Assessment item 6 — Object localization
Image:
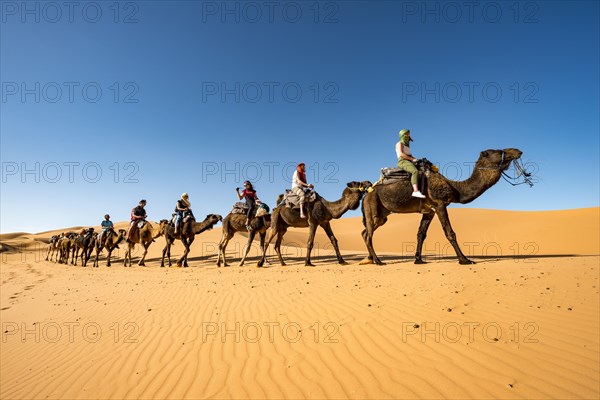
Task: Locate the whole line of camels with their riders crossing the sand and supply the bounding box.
[46,130,533,267]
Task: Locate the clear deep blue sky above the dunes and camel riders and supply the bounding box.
[0,1,600,232]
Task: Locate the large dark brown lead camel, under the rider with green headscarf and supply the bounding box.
[361,148,523,265]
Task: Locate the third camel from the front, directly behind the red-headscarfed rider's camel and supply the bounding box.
[217,208,271,267]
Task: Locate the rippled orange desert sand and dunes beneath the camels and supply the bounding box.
[0,208,600,399]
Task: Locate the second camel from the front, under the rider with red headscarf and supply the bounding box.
[258,181,371,267]
